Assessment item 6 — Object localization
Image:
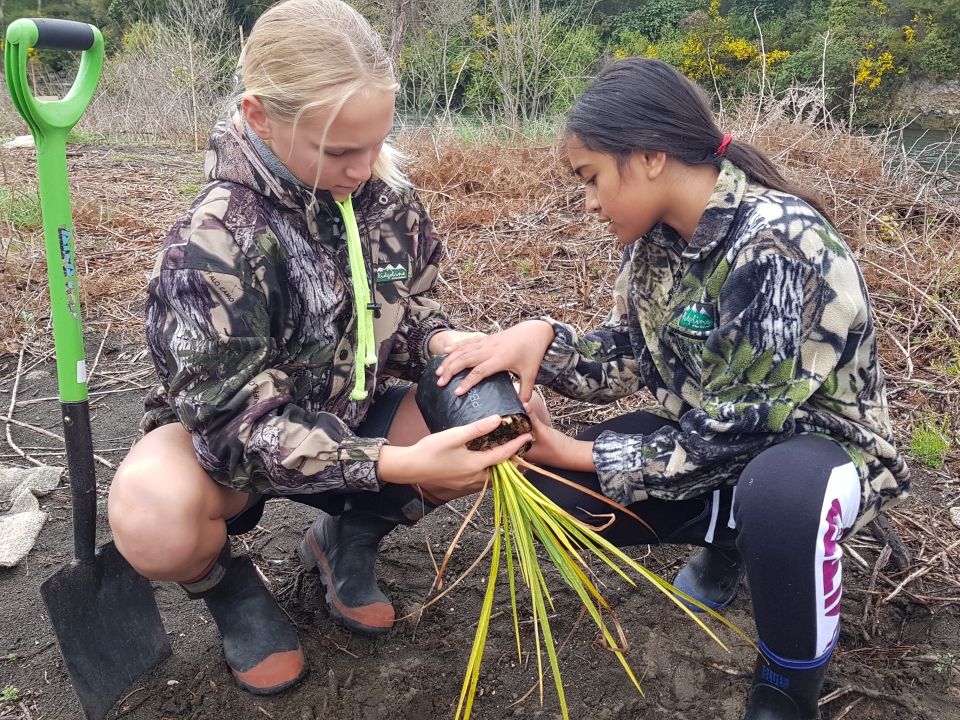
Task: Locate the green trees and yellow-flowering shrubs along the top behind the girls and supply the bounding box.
[0,0,960,140]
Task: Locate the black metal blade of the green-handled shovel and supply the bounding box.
[40,543,170,720]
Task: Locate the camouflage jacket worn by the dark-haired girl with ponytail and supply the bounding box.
[538,161,909,527]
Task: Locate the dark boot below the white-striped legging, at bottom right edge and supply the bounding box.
[744,653,832,720]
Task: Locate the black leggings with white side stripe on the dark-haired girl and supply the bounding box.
[530,411,860,666]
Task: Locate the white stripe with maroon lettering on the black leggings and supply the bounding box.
[813,462,860,657]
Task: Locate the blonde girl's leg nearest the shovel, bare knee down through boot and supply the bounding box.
[108,423,306,695]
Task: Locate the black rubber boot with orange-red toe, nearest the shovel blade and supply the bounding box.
[181,542,307,695]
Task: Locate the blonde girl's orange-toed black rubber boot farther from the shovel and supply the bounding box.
[300,484,437,635]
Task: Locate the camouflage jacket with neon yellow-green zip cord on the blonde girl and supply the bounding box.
[143,121,449,494]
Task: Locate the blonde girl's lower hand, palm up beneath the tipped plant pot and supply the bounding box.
[378,415,533,500]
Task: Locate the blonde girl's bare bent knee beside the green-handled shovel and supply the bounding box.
[107,423,249,582]
